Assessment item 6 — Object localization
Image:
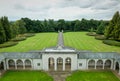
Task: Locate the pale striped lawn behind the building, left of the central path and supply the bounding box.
[0,33,58,52]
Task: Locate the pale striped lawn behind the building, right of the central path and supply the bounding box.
[64,32,120,52]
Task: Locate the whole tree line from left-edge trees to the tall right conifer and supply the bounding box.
[0,16,108,44]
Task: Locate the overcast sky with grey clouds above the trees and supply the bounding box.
[0,0,120,20]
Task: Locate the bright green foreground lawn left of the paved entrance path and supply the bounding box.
[0,71,53,81]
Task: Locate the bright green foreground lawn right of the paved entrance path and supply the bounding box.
[66,71,120,81]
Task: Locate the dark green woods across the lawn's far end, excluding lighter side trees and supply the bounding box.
[21,18,108,32]
